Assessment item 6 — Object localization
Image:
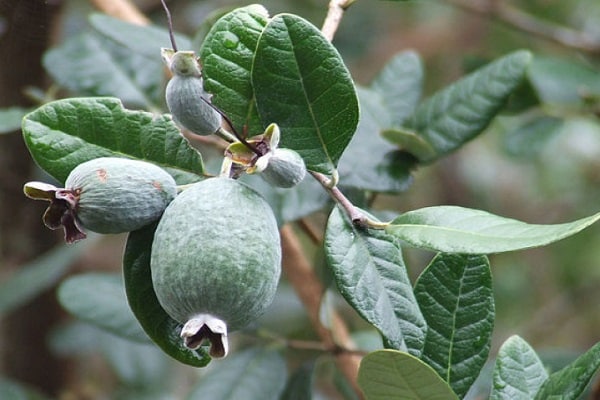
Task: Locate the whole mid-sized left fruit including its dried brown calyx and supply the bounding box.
[23,157,177,243]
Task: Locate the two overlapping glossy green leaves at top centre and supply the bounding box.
[200,5,358,174]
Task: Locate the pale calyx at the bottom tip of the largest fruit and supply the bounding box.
[180,314,229,358]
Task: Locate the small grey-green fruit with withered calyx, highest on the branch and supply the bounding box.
[161,48,222,136]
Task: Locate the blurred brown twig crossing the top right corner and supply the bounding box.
[446,0,600,54]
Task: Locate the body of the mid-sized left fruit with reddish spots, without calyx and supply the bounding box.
[66,157,177,233]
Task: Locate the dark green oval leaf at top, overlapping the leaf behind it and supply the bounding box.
[252,14,358,174]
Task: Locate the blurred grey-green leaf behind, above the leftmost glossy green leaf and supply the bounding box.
[43,33,164,110]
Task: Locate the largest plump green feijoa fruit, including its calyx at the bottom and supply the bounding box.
[150,177,281,358]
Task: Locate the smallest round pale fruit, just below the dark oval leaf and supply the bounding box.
[260,148,306,188]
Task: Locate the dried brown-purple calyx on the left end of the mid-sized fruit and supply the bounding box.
[23,181,87,244]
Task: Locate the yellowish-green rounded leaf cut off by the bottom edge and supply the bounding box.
[358,350,458,400]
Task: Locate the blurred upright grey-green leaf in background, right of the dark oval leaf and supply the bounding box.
[370,51,423,128]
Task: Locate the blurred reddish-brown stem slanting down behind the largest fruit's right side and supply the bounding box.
[281,225,362,398]
